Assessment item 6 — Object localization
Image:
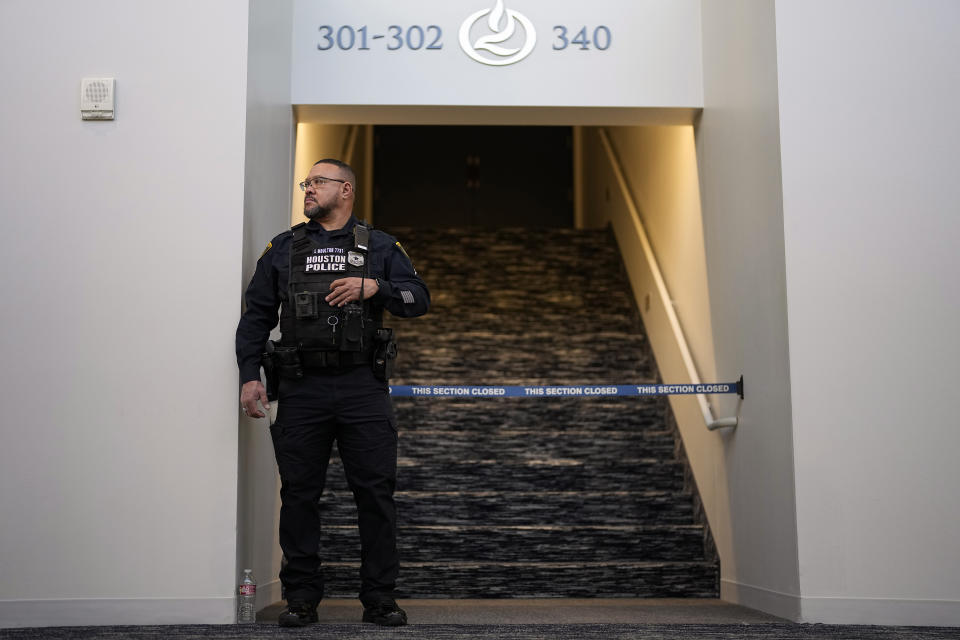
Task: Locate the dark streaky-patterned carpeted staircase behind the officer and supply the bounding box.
[323,229,719,598]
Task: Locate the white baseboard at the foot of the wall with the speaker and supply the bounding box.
[0,597,236,628]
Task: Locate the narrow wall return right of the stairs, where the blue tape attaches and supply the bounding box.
[697,0,809,618]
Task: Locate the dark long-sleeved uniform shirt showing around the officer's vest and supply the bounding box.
[237,216,430,383]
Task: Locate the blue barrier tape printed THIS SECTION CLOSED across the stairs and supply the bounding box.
[390,378,743,398]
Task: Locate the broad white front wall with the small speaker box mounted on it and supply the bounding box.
[0,0,247,626]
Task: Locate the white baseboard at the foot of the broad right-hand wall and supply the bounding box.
[801,598,960,627]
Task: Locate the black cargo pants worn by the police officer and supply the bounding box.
[270,365,400,605]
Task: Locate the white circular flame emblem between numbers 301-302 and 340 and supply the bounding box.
[460,0,537,67]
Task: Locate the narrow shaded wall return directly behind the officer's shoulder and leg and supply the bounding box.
[238,0,294,607]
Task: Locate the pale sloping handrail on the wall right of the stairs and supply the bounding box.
[599,127,743,431]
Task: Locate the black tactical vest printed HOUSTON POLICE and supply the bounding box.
[280,223,383,366]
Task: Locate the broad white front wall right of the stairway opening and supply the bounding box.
[776,0,960,625]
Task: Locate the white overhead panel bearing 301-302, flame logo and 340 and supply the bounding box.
[291,0,703,108]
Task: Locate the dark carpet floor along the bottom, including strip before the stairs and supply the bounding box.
[0,598,960,640]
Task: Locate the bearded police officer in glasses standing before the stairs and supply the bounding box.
[237,159,430,626]
